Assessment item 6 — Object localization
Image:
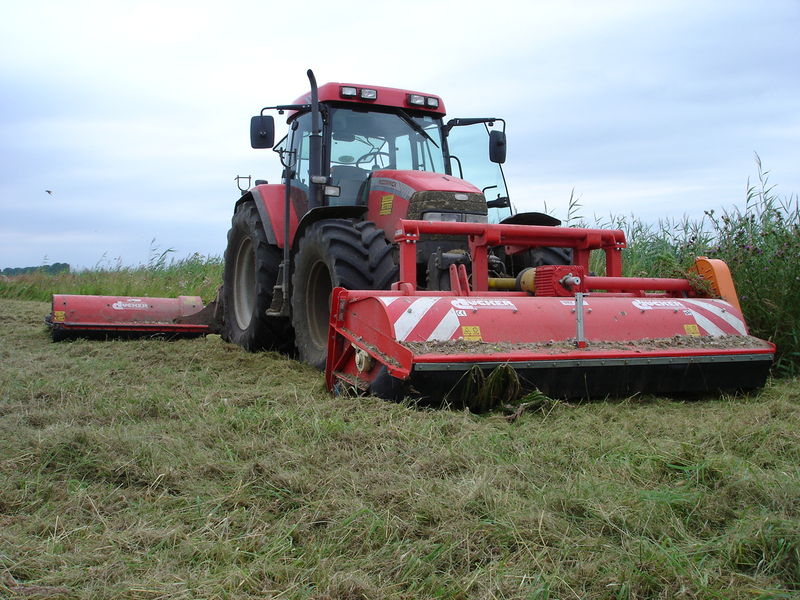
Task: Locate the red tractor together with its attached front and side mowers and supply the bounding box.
[48,71,775,406]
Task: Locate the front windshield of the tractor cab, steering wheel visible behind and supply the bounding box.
[330,108,445,173]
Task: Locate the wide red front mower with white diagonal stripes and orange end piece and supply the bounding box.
[326,220,775,402]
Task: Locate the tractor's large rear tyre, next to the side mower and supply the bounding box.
[222,202,294,352]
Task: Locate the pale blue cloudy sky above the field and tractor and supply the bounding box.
[0,0,800,268]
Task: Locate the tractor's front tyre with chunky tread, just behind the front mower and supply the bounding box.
[292,219,397,369]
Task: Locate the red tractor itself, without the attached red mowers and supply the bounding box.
[222,71,569,368]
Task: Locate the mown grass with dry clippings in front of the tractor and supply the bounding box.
[0,299,800,600]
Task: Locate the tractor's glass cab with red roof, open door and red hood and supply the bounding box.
[251,83,511,228]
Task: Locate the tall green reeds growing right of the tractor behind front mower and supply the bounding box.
[580,155,800,375]
